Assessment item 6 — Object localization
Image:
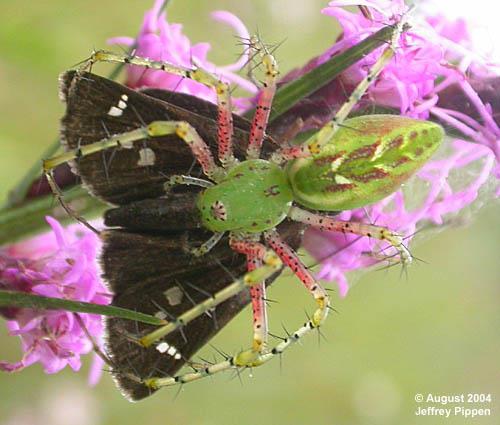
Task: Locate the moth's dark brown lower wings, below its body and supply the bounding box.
[102,230,249,400]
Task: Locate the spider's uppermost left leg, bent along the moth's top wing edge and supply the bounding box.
[82,50,236,168]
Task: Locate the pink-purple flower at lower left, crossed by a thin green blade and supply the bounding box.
[0,217,111,383]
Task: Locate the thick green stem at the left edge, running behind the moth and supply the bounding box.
[0,187,106,246]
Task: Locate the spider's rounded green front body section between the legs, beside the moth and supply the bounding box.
[198,159,293,233]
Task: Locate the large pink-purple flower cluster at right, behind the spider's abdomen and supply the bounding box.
[304,0,500,296]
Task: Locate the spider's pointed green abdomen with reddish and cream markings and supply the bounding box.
[287,115,444,211]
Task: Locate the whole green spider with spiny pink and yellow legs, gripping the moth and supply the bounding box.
[44,17,443,389]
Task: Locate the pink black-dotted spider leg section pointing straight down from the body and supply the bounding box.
[229,235,268,355]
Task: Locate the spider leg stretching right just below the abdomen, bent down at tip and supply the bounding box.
[288,206,412,265]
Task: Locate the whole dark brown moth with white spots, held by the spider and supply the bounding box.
[61,71,303,400]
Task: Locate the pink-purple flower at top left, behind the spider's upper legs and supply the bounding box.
[108,0,257,108]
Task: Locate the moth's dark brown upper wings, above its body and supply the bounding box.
[60,71,276,205]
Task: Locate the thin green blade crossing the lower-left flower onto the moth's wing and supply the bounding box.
[0,291,167,326]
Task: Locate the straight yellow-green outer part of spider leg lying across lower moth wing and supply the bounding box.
[137,250,282,347]
